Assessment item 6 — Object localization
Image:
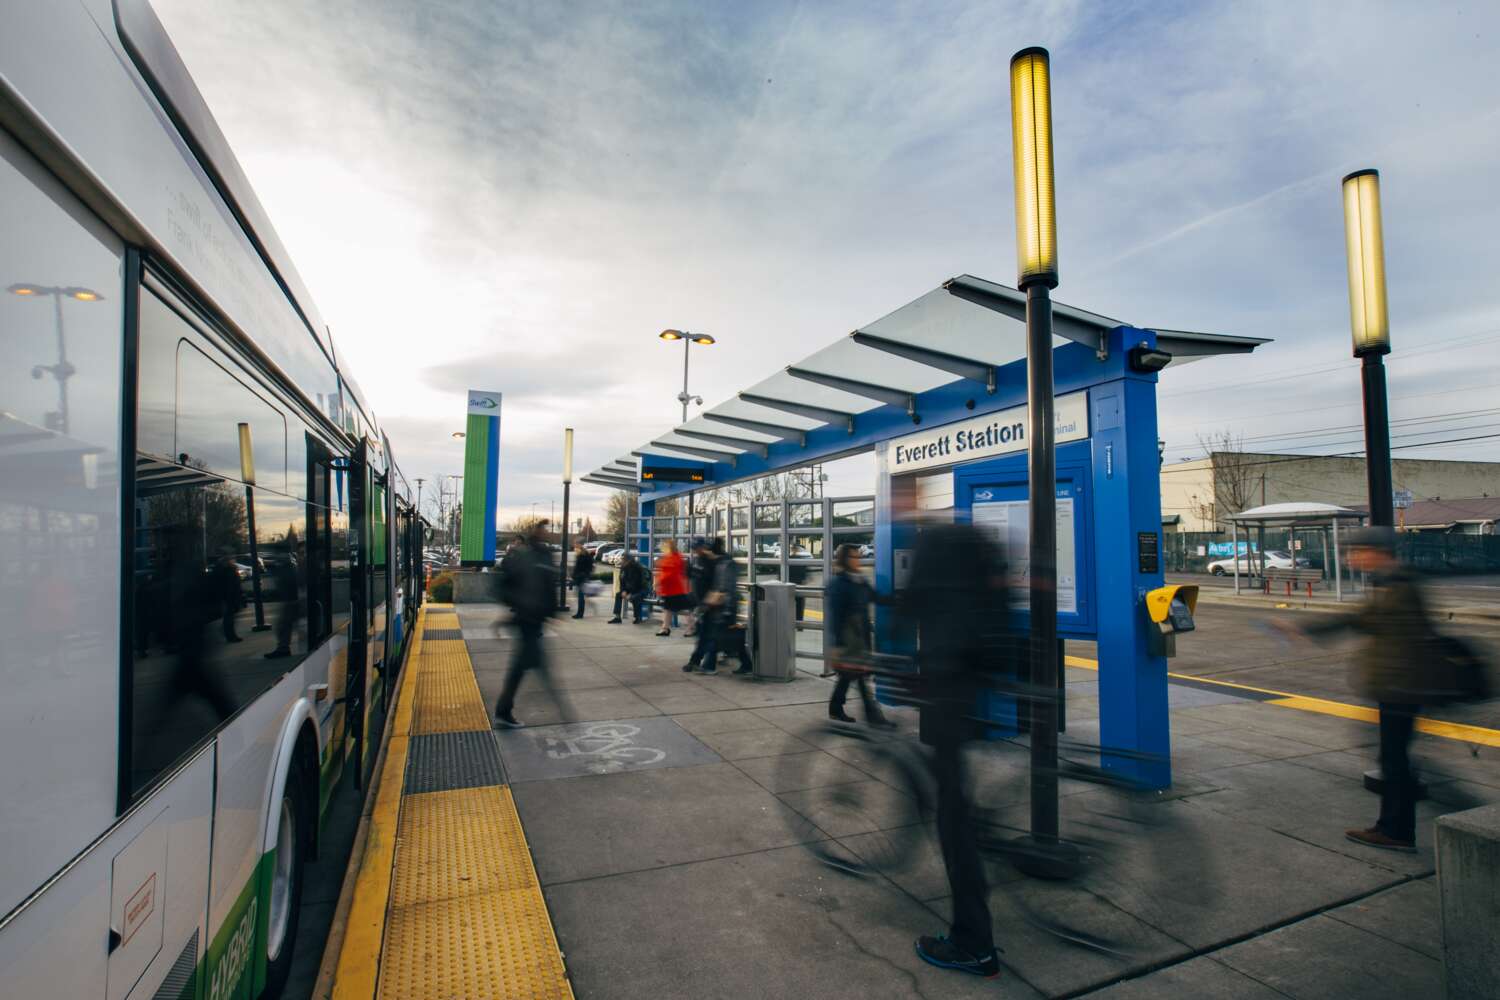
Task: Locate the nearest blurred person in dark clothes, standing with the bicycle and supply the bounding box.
[905,525,1014,978]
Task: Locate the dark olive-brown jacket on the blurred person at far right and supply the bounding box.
[1304,567,1439,705]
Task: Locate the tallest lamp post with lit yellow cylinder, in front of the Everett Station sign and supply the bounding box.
[1011,48,1071,877]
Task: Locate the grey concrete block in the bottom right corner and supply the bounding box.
[1437,805,1500,1000]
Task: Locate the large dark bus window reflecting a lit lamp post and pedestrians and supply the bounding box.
[129,289,308,792]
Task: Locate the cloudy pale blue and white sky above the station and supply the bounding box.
[155,0,1500,520]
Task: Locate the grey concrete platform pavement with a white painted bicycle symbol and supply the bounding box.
[458,604,1500,1000]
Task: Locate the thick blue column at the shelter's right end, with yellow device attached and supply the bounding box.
[1089,327,1172,789]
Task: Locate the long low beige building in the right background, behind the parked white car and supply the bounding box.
[1161,451,1500,534]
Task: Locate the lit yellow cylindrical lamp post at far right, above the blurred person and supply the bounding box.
[1344,169,1395,528]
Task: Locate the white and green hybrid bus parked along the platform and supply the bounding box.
[0,0,420,1000]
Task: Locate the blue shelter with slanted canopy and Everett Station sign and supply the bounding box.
[585,274,1266,787]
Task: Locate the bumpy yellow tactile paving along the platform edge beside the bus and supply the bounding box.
[333,606,573,1000]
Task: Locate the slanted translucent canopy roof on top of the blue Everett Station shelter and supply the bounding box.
[582,274,1266,489]
